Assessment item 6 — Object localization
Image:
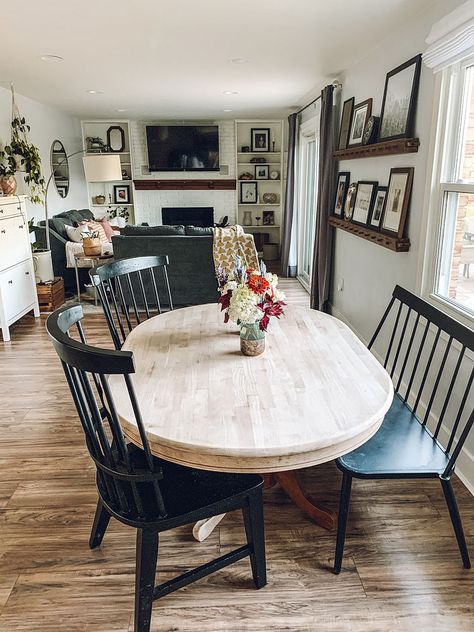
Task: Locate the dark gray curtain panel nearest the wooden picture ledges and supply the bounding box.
[310,85,337,312]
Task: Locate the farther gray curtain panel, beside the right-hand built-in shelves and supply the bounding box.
[281,114,298,277]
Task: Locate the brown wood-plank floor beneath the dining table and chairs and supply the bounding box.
[0,280,474,632]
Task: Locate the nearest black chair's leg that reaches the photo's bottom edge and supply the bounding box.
[134,529,159,632]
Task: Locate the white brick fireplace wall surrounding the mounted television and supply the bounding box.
[130,121,235,225]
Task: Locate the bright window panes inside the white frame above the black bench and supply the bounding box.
[430,59,474,318]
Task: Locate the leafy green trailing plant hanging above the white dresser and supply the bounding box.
[0,116,45,204]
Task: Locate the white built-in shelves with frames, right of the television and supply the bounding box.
[235,119,284,255]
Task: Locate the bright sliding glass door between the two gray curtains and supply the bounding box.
[298,118,319,290]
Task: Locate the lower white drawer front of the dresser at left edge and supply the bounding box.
[0,261,36,321]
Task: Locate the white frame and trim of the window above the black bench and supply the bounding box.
[417,57,474,327]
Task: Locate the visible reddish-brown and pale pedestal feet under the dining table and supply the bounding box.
[193,470,336,542]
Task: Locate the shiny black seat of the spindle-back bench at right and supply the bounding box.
[336,395,449,478]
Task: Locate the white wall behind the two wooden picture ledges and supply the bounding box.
[332,0,474,490]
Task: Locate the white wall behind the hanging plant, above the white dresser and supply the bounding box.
[0,88,88,223]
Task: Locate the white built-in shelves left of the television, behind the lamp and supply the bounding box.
[82,120,134,223]
